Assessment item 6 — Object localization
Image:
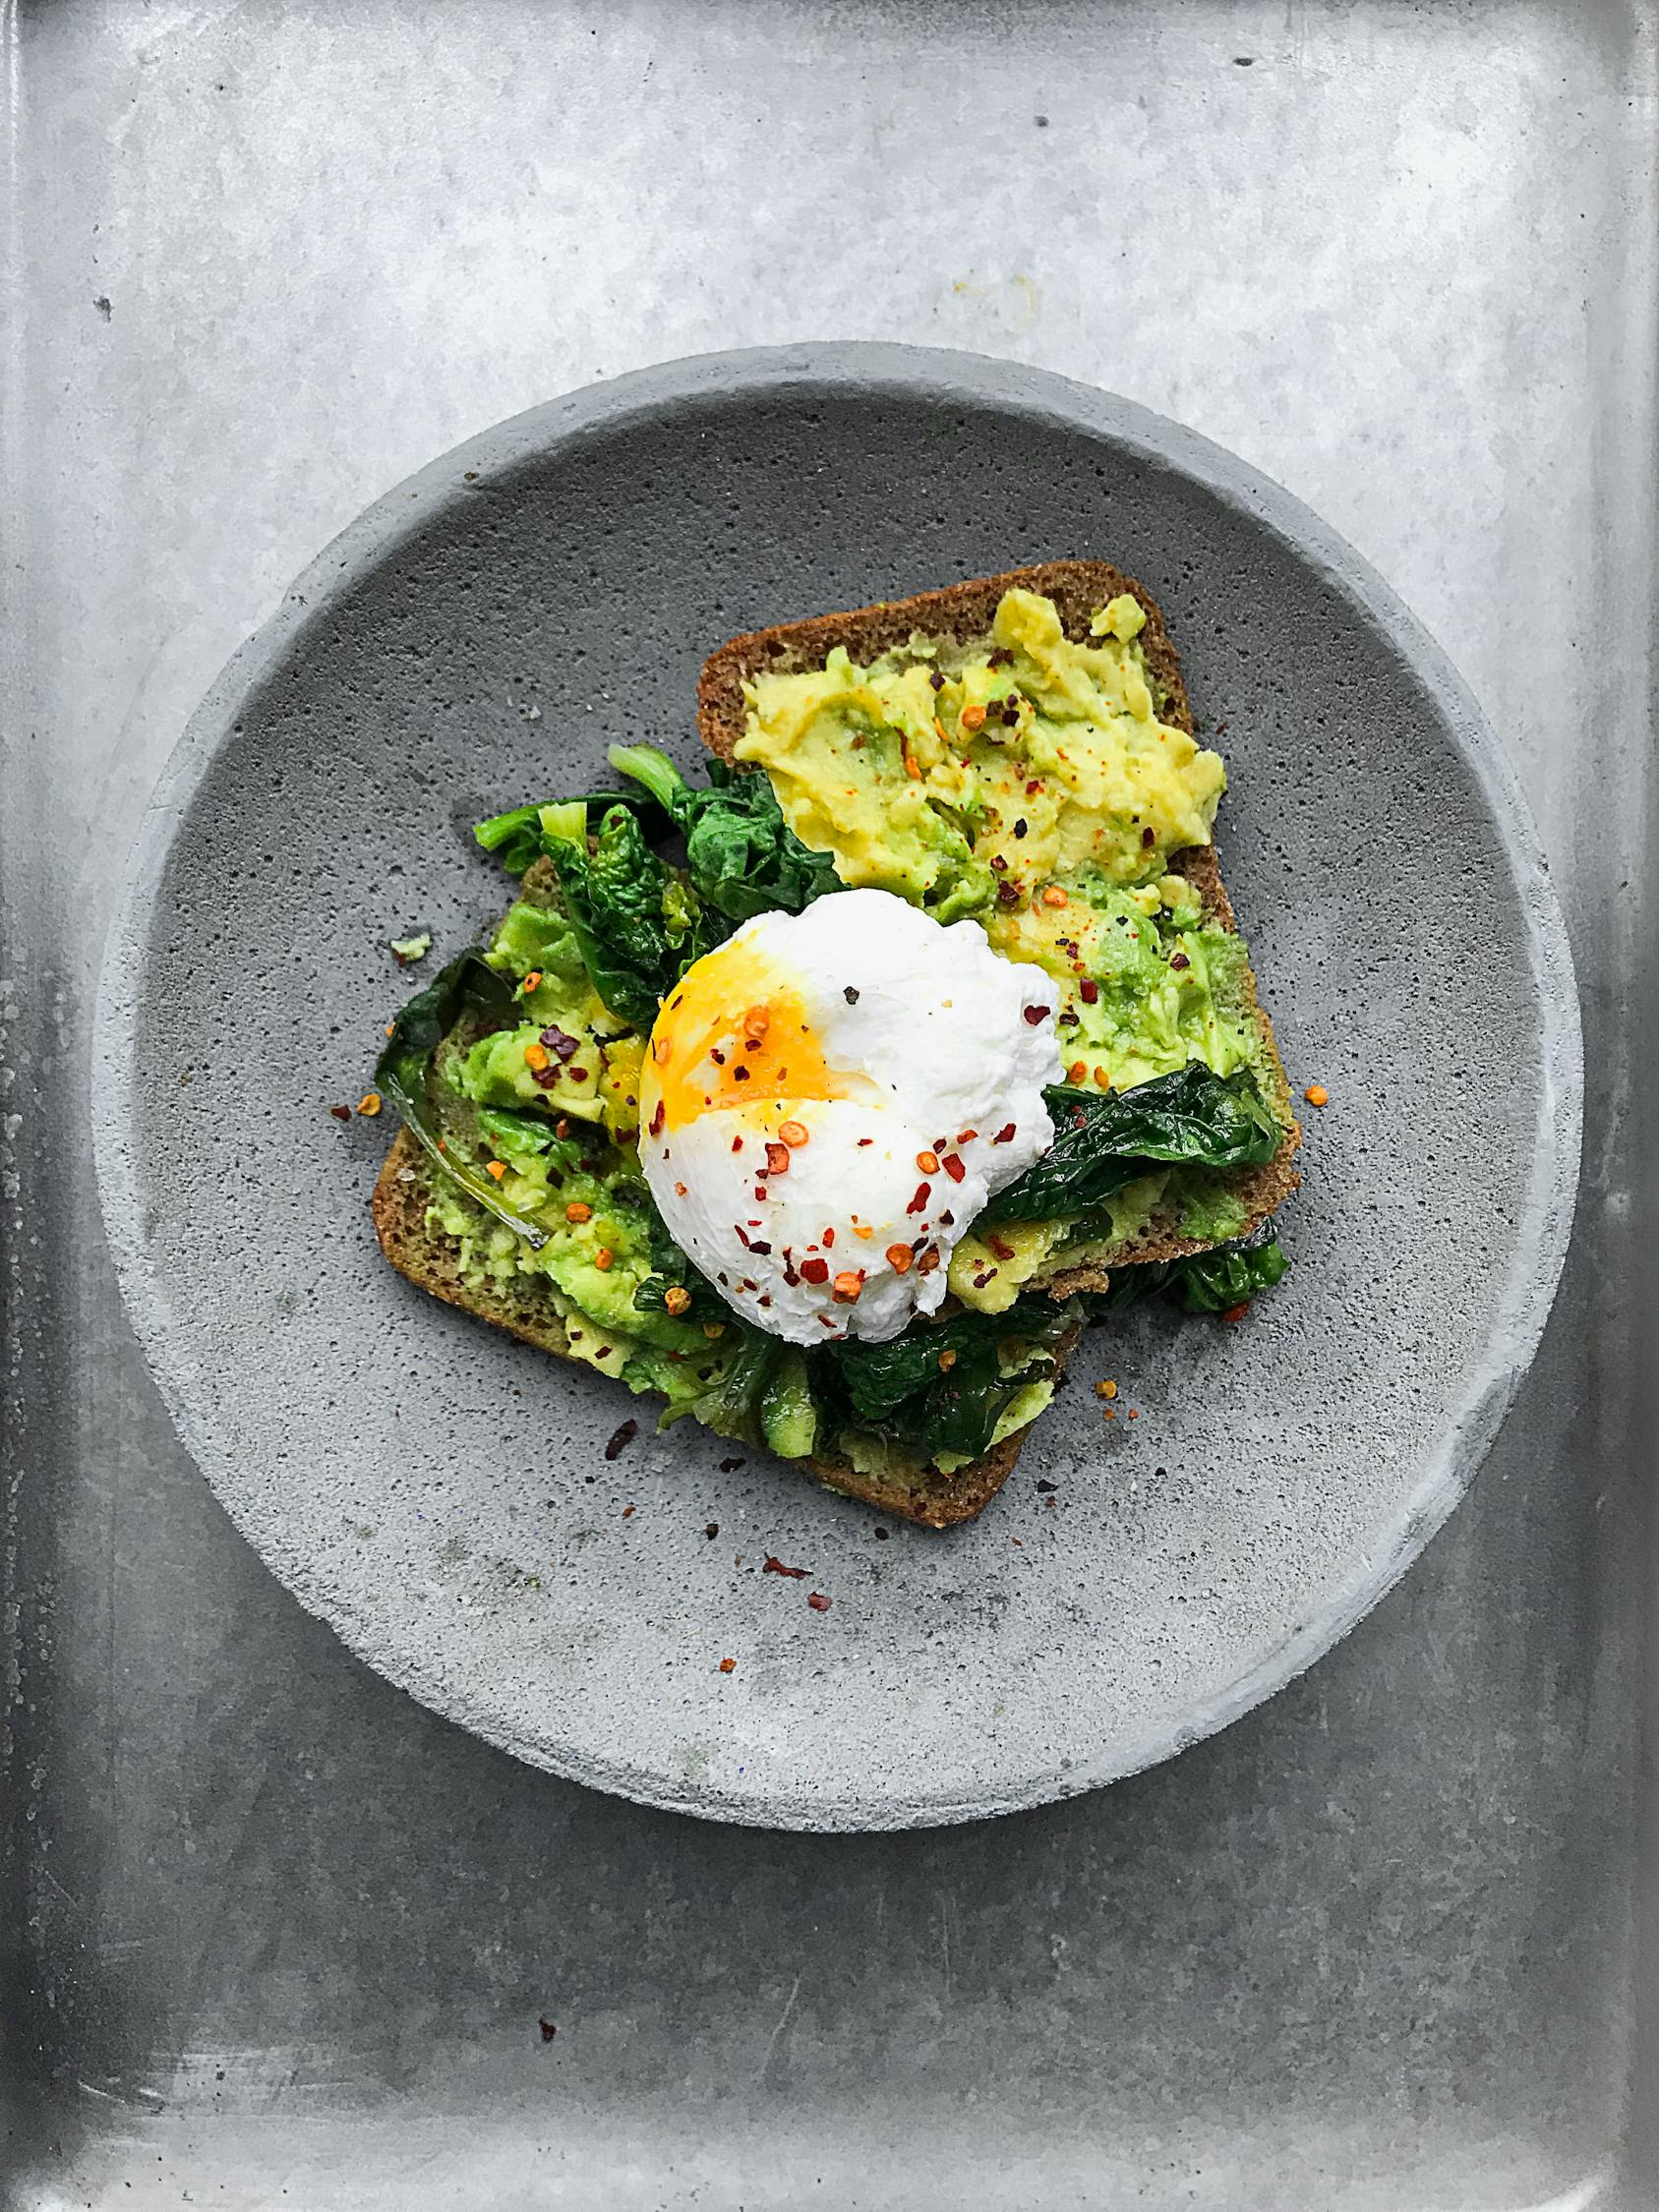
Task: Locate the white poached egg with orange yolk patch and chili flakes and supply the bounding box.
[639,890,1059,1345]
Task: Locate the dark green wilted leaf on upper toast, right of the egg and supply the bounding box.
[979,1060,1283,1228]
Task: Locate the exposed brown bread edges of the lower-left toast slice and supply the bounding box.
[372,1131,1075,1529]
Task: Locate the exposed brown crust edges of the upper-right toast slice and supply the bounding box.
[697,559,1301,1299]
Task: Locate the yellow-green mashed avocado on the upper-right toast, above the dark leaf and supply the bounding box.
[737,591,1263,1088]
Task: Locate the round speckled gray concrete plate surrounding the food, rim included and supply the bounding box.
[95,347,1579,1828]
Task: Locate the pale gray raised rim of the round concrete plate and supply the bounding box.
[90,341,1584,1834]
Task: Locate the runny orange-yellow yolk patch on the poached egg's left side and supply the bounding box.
[641,943,869,1131]
